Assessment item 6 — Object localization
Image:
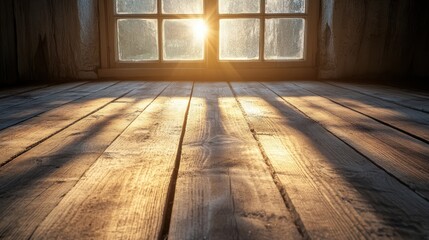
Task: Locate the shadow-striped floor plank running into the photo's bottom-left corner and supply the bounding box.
[0,80,167,239]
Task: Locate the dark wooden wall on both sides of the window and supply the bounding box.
[0,0,429,85]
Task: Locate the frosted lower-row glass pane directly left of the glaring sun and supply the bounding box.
[163,19,205,60]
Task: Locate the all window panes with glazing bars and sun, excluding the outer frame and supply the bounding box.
[111,0,309,66]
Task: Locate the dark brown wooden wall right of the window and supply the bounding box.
[319,0,429,84]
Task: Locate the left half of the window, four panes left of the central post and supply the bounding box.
[115,0,205,62]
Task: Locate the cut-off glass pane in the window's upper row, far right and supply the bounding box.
[265,0,305,13]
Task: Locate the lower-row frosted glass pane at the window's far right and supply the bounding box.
[264,18,305,60]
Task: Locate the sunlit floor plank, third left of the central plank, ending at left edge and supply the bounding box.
[0,82,144,166]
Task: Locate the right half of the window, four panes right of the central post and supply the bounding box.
[219,0,306,60]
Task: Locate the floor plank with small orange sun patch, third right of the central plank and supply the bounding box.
[295,82,429,143]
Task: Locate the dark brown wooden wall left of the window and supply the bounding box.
[0,0,99,85]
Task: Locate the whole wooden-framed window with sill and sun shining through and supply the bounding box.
[100,0,319,79]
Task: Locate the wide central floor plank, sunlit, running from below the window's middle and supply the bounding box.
[168,83,301,239]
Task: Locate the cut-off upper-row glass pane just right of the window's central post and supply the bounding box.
[219,0,261,14]
